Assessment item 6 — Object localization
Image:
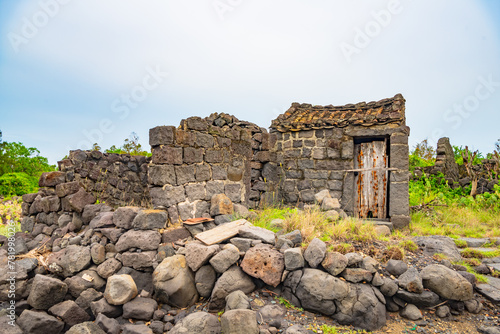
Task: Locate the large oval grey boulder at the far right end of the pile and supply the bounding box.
[420,264,474,301]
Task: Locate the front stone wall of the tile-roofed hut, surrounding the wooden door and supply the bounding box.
[276,124,409,227]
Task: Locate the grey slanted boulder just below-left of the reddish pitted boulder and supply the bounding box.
[209,266,255,311]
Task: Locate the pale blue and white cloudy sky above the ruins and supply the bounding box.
[0,0,500,163]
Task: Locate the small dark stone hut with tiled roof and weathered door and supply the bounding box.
[270,94,410,227]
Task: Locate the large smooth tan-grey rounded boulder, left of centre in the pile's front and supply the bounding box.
[153,255,199,308]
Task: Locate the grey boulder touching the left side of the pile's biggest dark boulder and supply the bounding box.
[296,269,349,316]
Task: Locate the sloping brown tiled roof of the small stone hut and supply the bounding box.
[271,94,405,132]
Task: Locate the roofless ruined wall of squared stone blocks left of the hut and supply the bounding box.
[149,114,276,221]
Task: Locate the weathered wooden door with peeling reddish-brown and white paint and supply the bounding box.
[354,140,388,219]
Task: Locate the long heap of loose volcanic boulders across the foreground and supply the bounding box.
[0,189,496,334]
